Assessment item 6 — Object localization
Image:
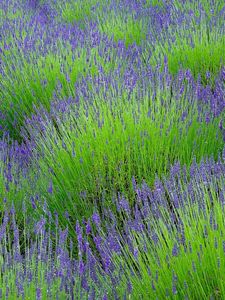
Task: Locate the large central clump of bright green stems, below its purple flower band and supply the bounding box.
[28,79,224,222]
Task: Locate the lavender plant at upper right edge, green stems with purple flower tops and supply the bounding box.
[144,0,225,86]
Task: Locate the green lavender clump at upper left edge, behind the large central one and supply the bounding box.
[0,38,120,138]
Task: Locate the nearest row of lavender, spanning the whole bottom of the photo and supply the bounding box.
[0,150,225,299]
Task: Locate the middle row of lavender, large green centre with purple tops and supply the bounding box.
[0,62,225,227]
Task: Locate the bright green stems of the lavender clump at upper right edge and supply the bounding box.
[150,22,225,86]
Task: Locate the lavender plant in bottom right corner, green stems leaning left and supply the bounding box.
[97,151,225,299]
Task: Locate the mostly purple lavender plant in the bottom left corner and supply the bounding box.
[0,206,112,299]
